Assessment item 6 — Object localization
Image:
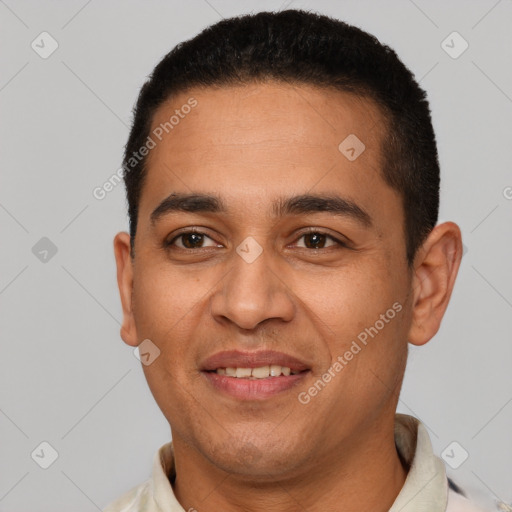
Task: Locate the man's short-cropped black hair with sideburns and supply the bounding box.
[123,9,440,267]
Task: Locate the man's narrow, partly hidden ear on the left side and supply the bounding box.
[114,232,139,347]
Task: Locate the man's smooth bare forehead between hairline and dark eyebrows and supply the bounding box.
[139,82,400,230]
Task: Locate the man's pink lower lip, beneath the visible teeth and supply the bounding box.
[201,371,309,400]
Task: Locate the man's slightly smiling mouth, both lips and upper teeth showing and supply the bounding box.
[201,351,311,400]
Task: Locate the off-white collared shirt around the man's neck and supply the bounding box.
[103,413,492,512]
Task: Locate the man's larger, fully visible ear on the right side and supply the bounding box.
[408,222,462,345]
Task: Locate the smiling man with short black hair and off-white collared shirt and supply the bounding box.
[106,10,490,512]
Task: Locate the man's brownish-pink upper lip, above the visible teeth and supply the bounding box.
[201,350,310,371]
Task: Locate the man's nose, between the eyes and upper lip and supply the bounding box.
[211,245,295,329]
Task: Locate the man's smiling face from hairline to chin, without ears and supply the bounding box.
[122,83,411,478]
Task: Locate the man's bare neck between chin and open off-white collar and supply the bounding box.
[173,418,407,512]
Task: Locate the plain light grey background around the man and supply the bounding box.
[0,0,512,512]
